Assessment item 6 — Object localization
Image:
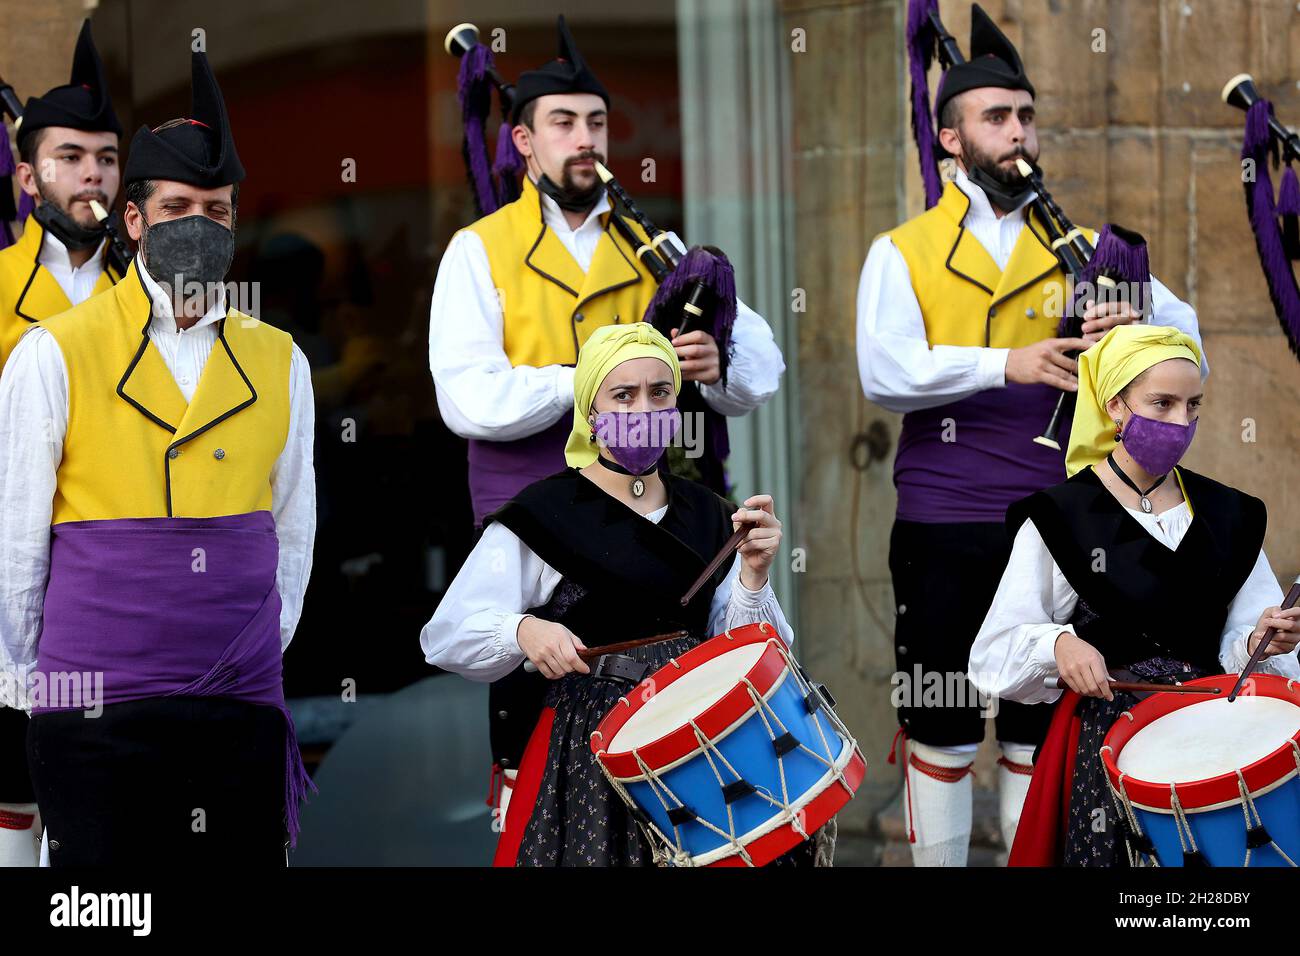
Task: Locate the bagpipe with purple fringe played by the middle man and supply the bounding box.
[443,23,736,494]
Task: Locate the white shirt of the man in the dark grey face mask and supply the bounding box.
[0,261,316,706]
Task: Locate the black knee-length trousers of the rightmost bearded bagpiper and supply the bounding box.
[889,520,1052,747]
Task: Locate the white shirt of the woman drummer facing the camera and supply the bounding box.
[420,496,794,680]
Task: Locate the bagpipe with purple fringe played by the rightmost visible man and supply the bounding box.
[906,0,1151,450]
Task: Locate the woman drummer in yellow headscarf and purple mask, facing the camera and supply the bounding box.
[420,323,815,866]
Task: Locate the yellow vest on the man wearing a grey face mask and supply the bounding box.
[42,261,293,524]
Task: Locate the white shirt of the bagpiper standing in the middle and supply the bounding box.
[429,182,785,441]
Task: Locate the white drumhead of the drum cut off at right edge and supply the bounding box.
[1117,697,1300,783]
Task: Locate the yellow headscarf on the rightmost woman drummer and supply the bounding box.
[1065,325,1201,476]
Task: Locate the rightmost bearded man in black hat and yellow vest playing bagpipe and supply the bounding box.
[857,0,1199,866]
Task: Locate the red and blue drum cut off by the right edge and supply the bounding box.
[1101,674,1300,866]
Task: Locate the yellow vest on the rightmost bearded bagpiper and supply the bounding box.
[887,182,1096,349]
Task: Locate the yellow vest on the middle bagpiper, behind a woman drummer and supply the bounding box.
[465,176,655,367]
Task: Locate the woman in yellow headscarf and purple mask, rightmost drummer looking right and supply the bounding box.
[970,325,1300,866]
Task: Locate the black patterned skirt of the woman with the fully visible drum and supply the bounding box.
[512,637,816,866]
